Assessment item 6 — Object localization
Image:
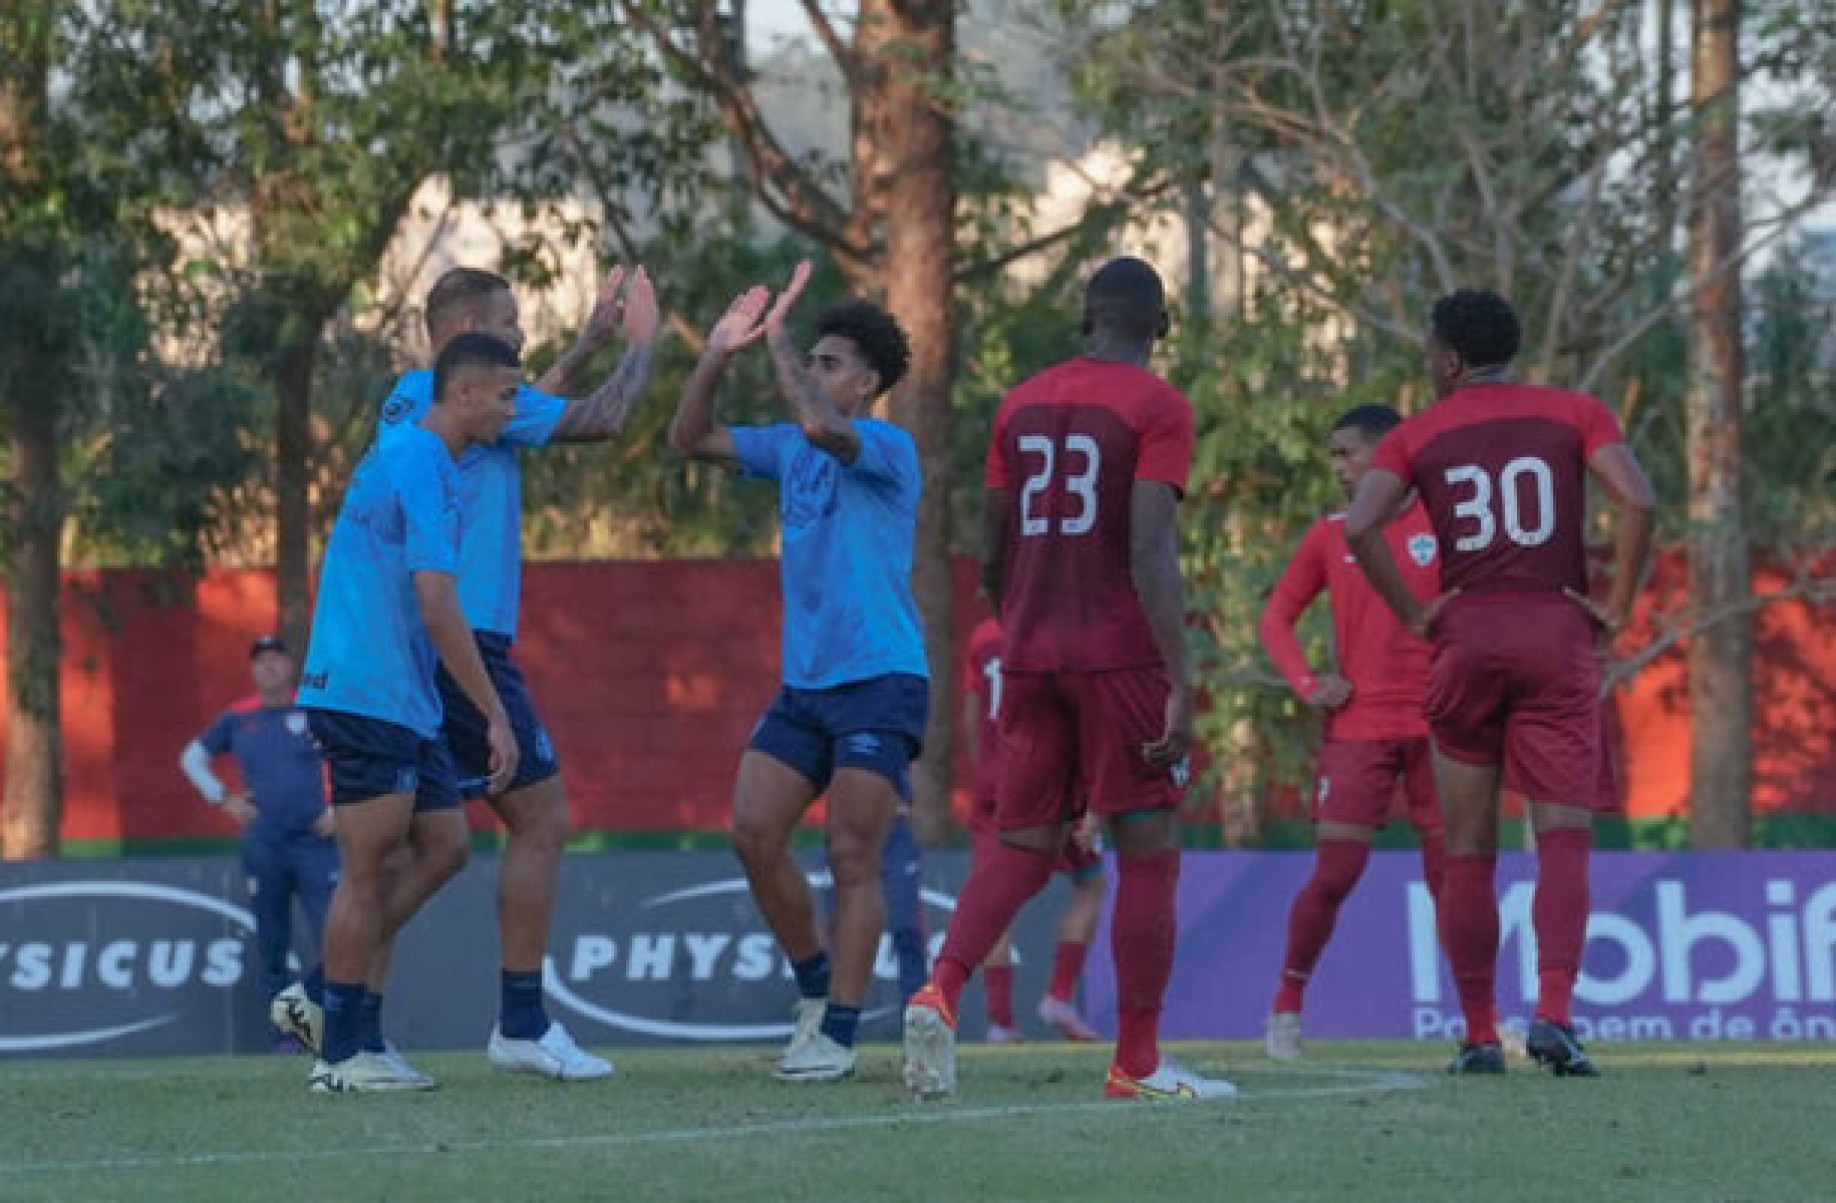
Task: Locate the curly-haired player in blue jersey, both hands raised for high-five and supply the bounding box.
[670,263,929,1082]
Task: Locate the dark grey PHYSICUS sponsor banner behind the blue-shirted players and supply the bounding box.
[0,852,1067,1058]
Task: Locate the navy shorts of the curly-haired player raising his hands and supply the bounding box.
[747,672,931,803]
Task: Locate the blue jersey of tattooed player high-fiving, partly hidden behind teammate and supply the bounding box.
[376,369,567,639]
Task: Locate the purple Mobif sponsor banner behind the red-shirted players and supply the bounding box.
[1085,852,1836,1041]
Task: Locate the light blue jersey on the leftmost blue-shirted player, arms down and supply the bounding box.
[299,426,459,738]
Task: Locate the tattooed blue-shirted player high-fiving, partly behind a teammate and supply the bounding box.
[277,268,659,1082]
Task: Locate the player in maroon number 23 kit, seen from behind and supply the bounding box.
[905,259,1236,1098]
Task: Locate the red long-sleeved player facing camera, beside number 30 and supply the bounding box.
[1261,406,1441,1062]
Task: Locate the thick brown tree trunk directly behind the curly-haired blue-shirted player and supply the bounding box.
[877,0,957,845]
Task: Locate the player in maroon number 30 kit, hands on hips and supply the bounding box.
[1346,290,1656,1076]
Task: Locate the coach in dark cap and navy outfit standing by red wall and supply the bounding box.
[178,635,338,1052]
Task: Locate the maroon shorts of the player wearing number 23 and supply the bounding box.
[995,667,1186,832]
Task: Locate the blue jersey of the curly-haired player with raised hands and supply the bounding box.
[733,419,931,689]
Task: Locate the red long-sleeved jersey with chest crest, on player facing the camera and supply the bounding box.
[1259,501,1441,740]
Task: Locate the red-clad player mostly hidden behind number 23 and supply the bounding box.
[962,619,1109,1045]
